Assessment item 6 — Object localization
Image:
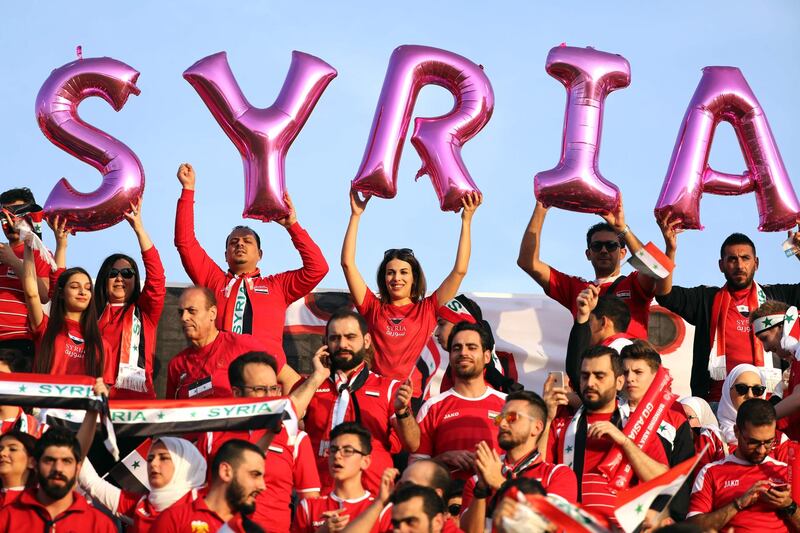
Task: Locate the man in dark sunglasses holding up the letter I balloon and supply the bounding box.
[517,200,660,339]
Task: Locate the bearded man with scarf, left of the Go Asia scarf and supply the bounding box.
[543,346,668,522]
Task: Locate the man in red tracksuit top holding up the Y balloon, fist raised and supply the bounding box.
[175,163,328,359]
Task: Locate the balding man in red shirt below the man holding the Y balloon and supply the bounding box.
[167,287,299,399]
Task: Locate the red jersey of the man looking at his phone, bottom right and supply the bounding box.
[687,454,789,532]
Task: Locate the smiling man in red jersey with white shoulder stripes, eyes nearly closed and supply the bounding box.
[395,322,506,479]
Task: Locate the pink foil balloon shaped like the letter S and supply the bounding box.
[36,57,144,231]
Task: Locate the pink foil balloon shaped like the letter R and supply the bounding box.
[352,45,494,211]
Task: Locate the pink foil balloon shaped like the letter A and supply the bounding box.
[655,67,800,231]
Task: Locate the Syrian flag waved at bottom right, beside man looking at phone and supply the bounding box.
[614,444,708,533]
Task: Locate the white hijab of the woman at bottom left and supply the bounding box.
[147,437,206,513]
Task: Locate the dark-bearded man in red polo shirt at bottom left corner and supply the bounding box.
[0,428,117,533]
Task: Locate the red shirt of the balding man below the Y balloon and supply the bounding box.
[162,331,286,400]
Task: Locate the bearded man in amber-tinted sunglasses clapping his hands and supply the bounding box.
[461,391,578,533]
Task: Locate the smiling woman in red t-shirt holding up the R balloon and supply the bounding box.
[342,191,483,381]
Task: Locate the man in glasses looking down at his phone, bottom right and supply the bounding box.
[688,398,800,532]
